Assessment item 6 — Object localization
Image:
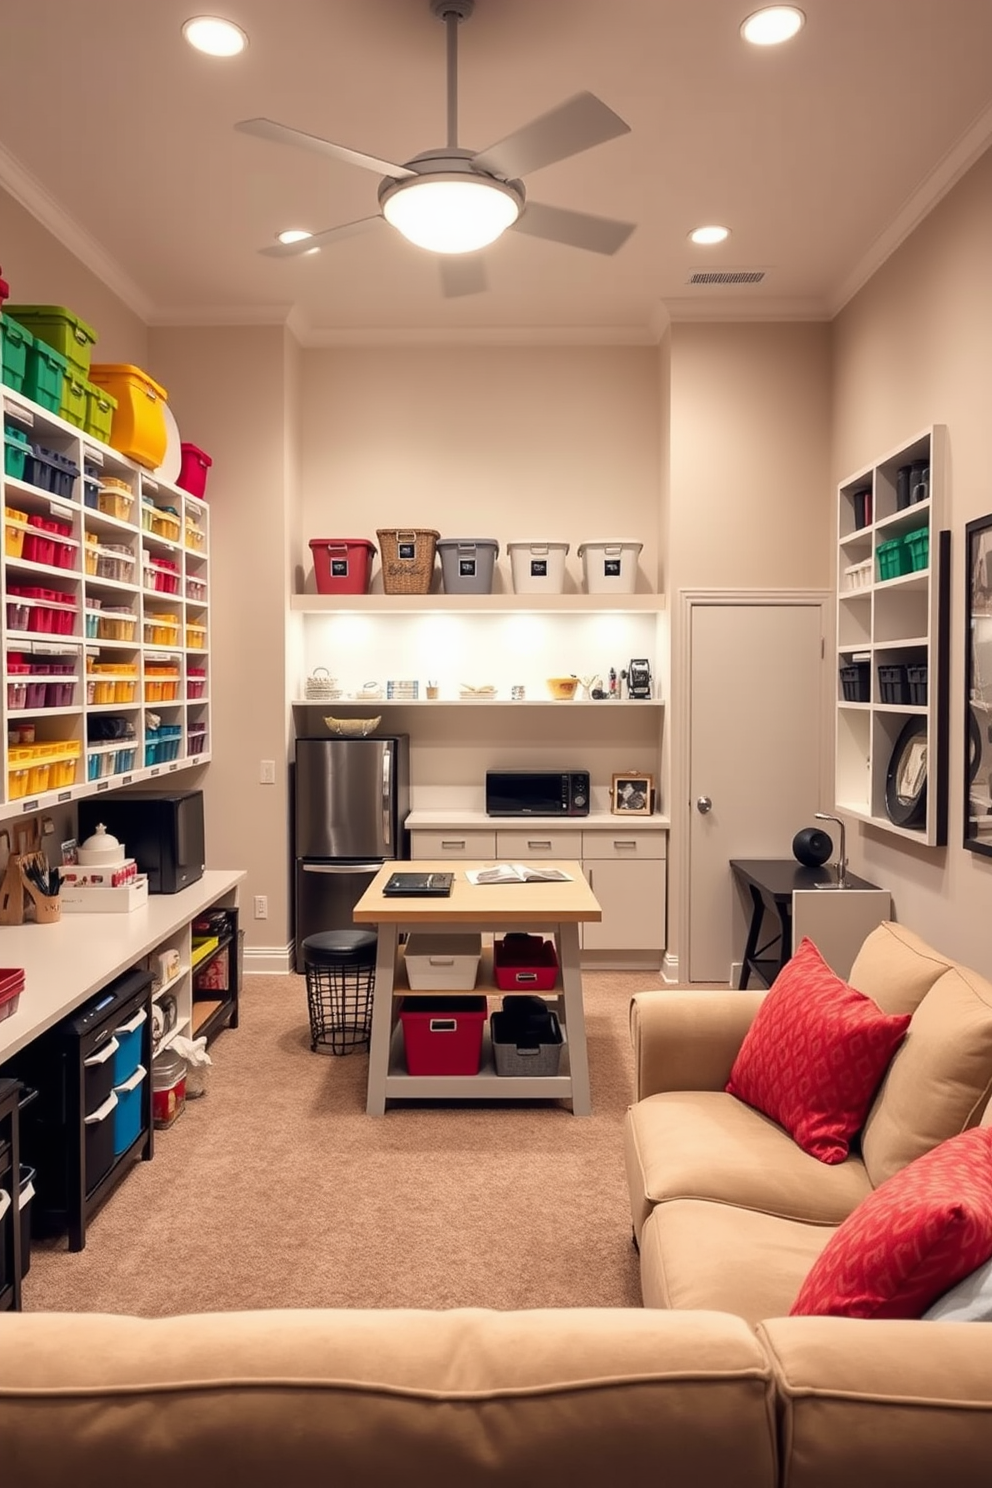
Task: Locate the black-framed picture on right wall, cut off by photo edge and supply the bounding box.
[964,515,992,857]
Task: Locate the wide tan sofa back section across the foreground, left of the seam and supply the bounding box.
[0,1308,775,1488]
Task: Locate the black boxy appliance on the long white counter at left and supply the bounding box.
[79,790,205,894]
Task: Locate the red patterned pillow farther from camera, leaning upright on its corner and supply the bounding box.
[726,937,910,1164]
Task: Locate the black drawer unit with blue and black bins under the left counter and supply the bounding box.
[4,969,153,1250]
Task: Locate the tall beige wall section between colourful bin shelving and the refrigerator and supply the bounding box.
[149,326,292,949]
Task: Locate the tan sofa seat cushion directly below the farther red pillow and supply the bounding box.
[625,1091,872,1238]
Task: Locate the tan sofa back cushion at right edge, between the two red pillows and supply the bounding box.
[861,966,992,1187]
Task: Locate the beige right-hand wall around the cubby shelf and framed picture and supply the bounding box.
[831,142,992,975]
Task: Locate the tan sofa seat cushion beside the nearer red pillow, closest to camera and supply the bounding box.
[641,1199,836,1327]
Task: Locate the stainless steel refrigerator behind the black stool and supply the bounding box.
[293,734,410,972]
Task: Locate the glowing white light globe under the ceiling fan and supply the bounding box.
[379,176,524,253]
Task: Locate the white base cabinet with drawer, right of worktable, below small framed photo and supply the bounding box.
[582,829,668,955]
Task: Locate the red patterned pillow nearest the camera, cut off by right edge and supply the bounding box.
[790,1126,992,1317]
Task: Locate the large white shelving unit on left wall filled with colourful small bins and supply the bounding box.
[0,377,210,817]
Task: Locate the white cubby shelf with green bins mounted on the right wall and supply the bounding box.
[834,424,950,847]
